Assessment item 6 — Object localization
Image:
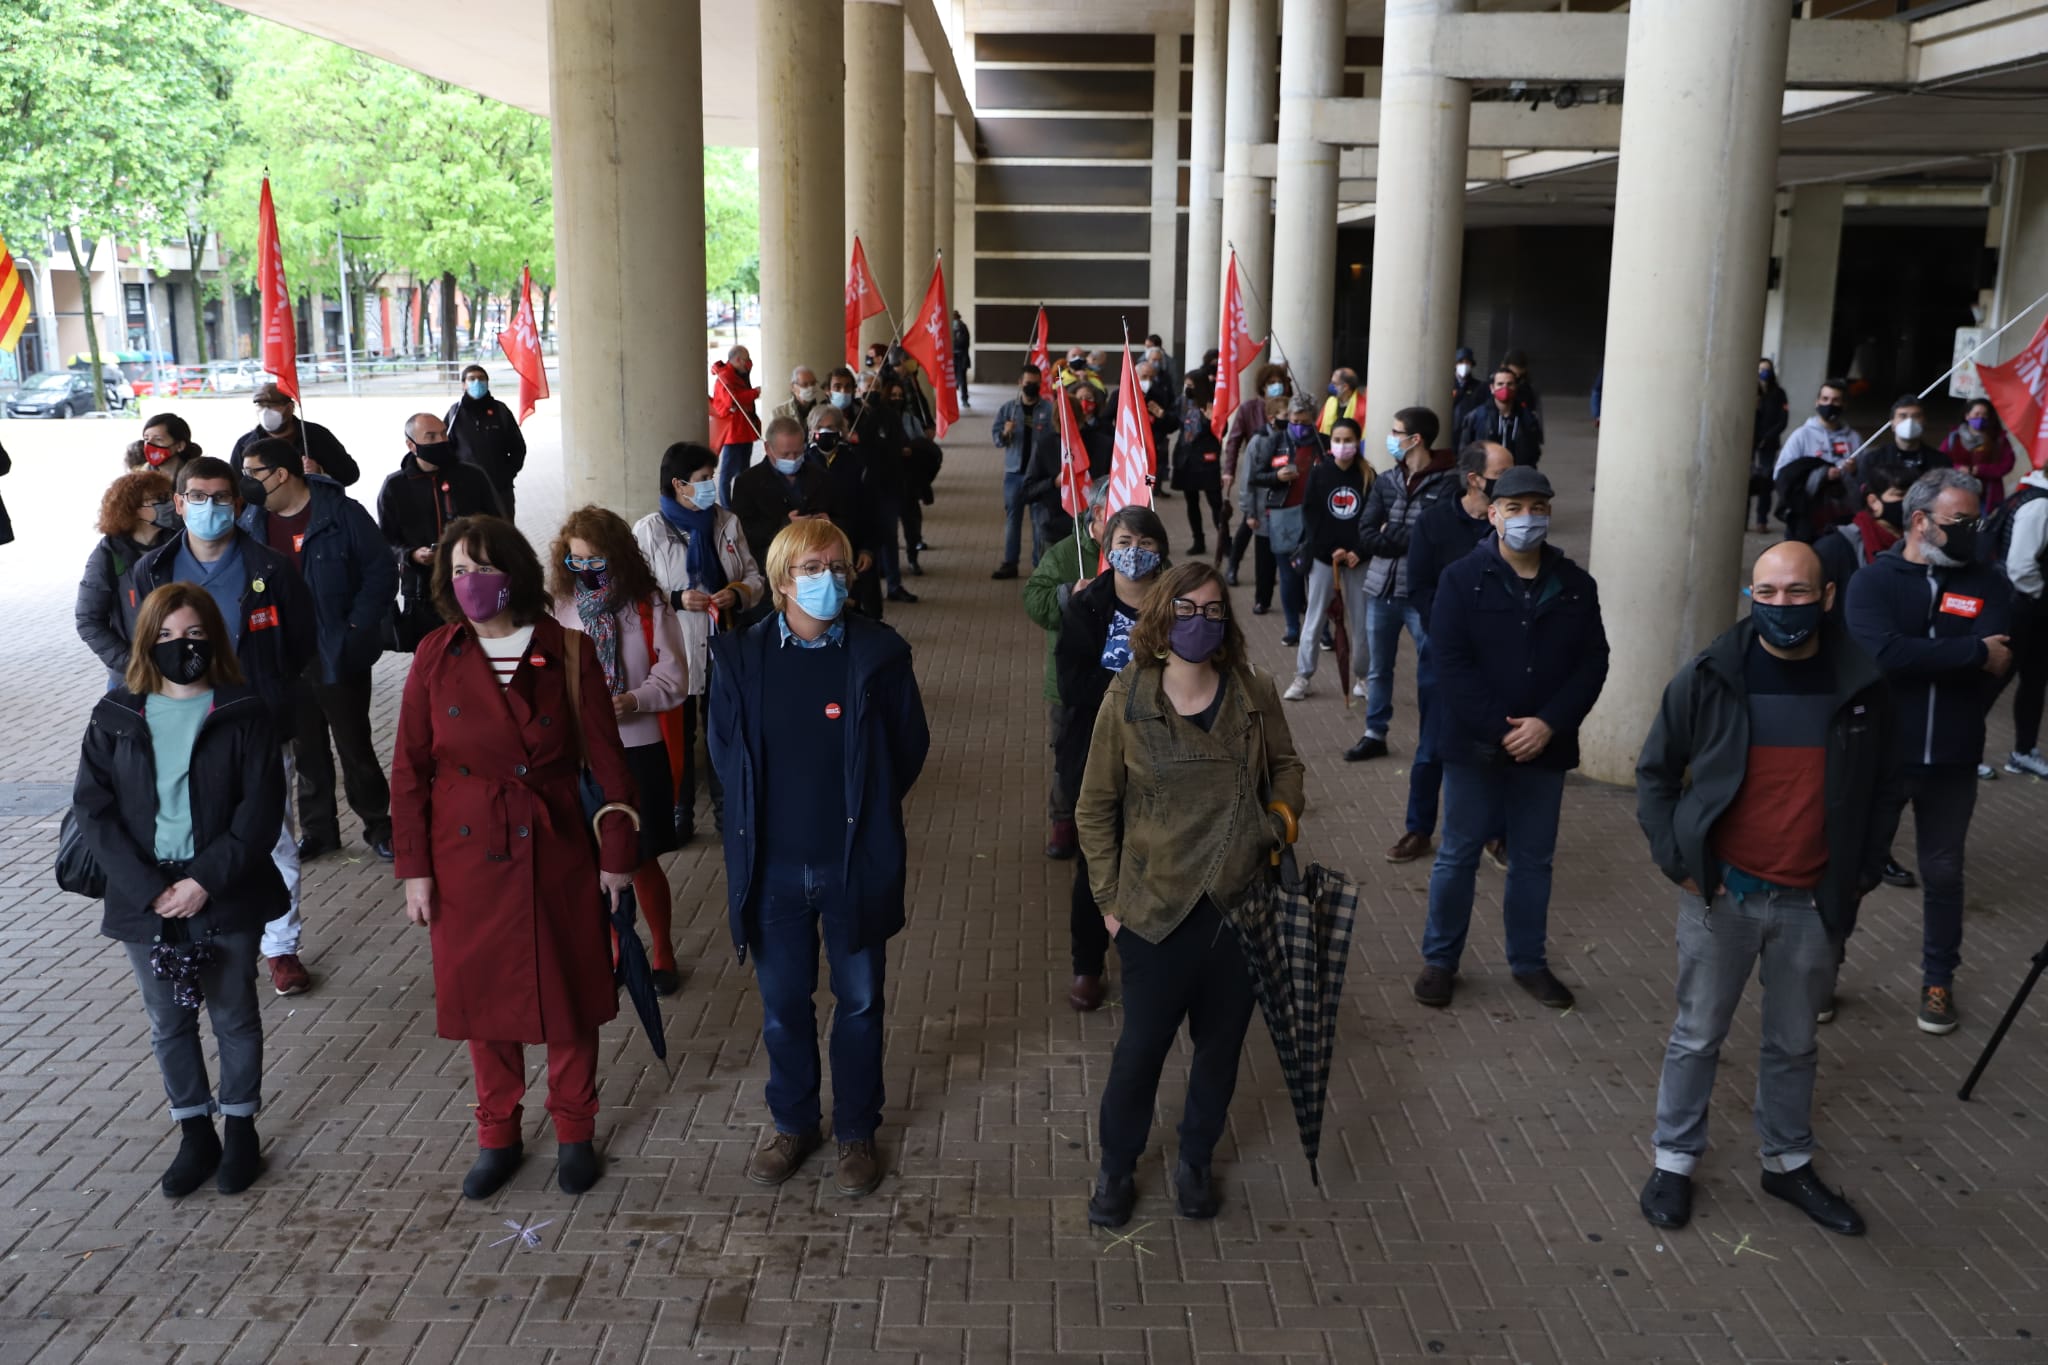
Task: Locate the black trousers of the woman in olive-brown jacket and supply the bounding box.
[1100,896,1255,1175]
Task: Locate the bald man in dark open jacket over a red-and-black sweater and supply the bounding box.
[1636,542,1905,1236]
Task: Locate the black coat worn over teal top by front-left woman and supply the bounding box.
[72,688,291,943]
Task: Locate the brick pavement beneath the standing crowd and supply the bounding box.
[0,391,2048,1365]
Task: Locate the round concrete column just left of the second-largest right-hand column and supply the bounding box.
[1272,0,1351,393]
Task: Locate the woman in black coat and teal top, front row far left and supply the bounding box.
[72,583,291,1199]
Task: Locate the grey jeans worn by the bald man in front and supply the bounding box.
[1655,888,1837,1175]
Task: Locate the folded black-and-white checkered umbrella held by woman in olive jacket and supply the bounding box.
[1225,806,1358,1185]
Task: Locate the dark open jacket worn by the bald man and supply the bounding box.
[1636,618,1905,943]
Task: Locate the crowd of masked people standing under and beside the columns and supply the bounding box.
[56,338,2048,1232]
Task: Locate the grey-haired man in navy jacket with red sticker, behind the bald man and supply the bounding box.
[1847,469,2013,1033]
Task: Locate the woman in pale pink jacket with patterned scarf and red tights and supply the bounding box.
[547,508,690,995]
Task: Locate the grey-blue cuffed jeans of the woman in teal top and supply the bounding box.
[123,931,262,1121]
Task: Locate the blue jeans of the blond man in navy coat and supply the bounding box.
[748,857,887,1142]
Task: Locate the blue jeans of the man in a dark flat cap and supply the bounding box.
[1421,763,1565,976]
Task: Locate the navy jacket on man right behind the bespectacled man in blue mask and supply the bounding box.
[242,475,397,684]
